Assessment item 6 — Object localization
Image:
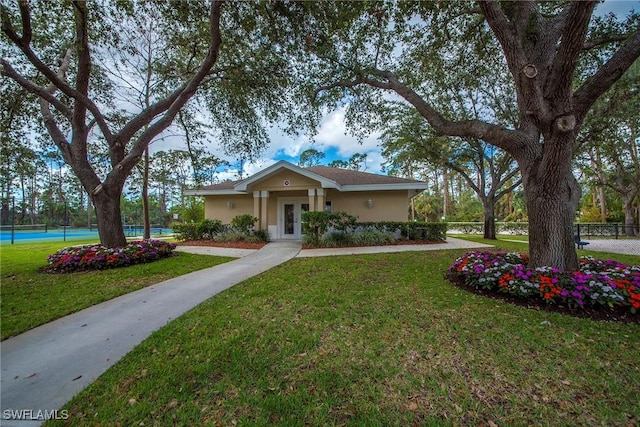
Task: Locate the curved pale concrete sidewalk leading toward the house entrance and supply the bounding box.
[0,242,300,427]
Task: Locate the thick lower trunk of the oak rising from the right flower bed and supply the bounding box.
[521,168,580,271]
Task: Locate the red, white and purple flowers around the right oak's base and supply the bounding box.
[448,252,640,313]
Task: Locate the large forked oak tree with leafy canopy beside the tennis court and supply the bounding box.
[2,0,290,246]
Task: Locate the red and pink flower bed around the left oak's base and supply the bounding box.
[45,240,176,273]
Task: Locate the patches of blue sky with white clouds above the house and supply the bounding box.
[194,0,640,180]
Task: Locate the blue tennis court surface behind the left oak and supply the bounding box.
[0,226,173,245]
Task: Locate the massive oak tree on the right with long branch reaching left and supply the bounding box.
[307,0,640,269]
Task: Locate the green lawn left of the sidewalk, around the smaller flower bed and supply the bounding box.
[0,241,232,339]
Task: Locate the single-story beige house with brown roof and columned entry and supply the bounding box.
[185,160,427,239]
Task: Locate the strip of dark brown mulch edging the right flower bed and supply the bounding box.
[445,274,640,324]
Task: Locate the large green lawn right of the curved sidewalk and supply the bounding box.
[47,239,640,426]
